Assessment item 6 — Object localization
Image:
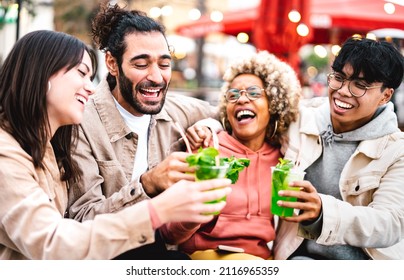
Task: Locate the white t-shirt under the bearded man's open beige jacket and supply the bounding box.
[114,98,151,180]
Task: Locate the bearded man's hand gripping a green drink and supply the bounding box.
[140,152,195,197]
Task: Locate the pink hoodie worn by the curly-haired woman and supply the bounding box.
[161,131,281,259]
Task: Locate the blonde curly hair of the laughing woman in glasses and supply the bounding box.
[219,51,302,146]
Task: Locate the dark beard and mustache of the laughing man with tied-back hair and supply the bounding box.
[119,71,168,115]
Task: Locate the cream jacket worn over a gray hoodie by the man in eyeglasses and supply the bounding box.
[274,102,404,260]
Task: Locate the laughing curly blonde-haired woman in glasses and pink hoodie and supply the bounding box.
[164,51,301,259]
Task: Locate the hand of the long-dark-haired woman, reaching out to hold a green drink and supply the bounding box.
[150,179,231,224]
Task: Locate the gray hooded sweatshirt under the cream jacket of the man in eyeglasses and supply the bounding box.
[291,103,399,260]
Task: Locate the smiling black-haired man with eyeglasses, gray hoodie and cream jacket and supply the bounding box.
[275,38,404,260]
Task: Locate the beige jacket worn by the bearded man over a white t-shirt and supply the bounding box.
[69,80,217,221]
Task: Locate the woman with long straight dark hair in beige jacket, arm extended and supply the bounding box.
[0,30,230,259]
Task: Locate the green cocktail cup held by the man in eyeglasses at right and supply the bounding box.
[271,167,305,217]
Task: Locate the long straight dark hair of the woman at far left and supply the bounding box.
[0,30,97,180]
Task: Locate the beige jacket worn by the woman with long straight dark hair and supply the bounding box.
[0,129,154,259]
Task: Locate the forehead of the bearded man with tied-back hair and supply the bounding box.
[123,31,170,59]
